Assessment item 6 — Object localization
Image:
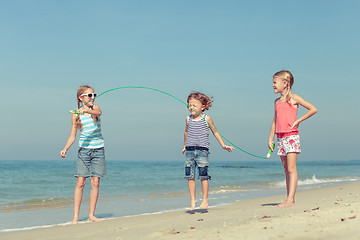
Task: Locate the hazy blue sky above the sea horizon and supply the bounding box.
[0,0,360,161]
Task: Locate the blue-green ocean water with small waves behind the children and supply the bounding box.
[0,160,360,234]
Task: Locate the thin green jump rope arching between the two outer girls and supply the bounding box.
[70,86,275,159]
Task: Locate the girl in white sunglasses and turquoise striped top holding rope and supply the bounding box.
[60,85,106,224]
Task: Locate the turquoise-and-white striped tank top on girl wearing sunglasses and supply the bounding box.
[79,115,104,149]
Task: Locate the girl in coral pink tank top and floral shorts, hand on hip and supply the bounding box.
[268,70,317,207]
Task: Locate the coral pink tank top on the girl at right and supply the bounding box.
[275,100,299,137]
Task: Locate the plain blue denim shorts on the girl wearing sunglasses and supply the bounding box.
[75,148,106,177]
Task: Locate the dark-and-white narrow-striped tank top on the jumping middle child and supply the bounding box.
[186,114,210,148]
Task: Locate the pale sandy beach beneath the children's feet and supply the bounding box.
[0,183,360,240]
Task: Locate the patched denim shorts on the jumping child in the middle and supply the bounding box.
[185,149,211,180]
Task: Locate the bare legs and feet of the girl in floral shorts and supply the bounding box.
[279,153,298,207]
